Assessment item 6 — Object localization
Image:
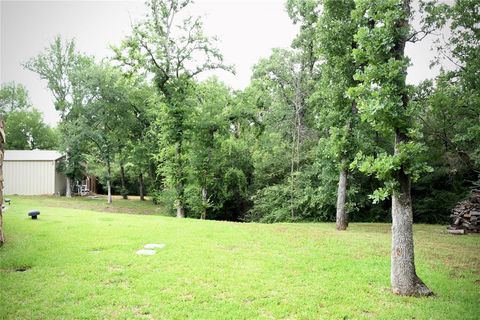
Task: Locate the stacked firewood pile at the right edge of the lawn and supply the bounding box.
[448,190,480,234]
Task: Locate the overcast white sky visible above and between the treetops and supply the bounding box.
[0,0,450,124]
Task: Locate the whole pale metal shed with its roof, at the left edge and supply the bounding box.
[3,150,66,195]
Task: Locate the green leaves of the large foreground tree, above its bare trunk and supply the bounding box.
[349,0,431,202]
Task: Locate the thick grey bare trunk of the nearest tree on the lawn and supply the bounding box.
[391,132,433,296]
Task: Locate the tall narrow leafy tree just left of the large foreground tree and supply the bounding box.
[318,0,357,230]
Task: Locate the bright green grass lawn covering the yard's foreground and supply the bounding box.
[0,197,480,319]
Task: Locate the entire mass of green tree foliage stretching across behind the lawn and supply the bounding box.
[12,0,480,222]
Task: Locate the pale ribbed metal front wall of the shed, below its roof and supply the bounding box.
[3,161,55,195]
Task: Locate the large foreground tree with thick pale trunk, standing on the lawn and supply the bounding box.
[352,0,432,295]
